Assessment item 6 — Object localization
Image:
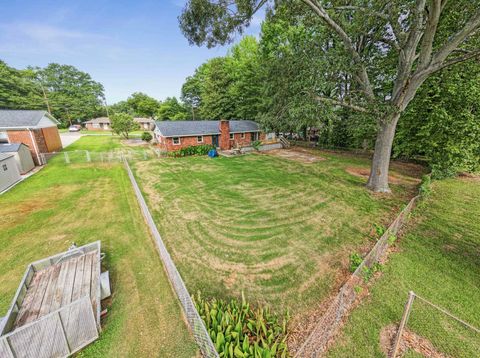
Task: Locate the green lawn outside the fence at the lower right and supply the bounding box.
[328,179,480,357]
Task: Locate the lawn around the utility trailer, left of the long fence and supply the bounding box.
[0,143,197,357]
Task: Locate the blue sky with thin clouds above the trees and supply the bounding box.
[0,0,261,104]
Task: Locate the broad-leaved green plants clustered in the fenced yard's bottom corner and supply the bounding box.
[193,293,288,358]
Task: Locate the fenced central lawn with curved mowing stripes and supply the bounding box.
[134,148,415,328]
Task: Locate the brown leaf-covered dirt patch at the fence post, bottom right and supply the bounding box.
[380,324,449,358]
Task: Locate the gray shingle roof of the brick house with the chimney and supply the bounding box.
[155,120,260,137]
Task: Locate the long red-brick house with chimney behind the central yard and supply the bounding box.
[155,120,265,151]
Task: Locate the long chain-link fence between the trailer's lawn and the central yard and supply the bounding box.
[124,160,219,357]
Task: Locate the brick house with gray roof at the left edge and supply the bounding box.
[0,110,62,165]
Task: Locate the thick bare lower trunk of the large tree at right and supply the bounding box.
[367,113,400,193]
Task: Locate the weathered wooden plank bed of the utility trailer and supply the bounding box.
[14,250,100,328]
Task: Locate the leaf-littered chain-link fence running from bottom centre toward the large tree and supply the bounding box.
[295,197,419,358]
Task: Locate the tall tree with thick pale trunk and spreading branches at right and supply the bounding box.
[179,0,480,192]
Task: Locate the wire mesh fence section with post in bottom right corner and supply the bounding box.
[390,292,480,358]
